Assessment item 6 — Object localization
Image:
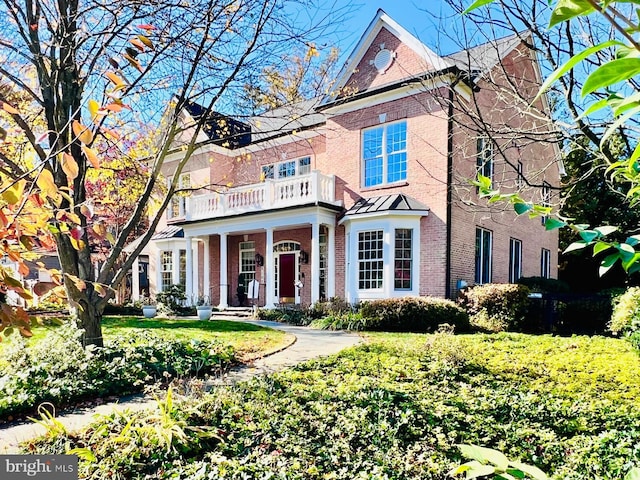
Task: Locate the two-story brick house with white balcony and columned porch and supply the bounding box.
[141,11,560,308]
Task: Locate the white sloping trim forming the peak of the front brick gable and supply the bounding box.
[320,9,453,106]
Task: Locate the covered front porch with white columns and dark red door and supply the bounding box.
[155,205,340,309]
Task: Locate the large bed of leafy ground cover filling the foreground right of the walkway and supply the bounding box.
[29,333,640,480]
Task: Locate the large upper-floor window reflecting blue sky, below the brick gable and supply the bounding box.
[362,121,407,187]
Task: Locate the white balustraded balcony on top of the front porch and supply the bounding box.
[185,170,340,221]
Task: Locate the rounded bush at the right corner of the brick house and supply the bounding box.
[459,283,529,332]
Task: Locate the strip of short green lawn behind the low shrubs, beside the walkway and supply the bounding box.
[0,317,293,361]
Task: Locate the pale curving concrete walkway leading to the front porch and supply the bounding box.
[0,318,361,454]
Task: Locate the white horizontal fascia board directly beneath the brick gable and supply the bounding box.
[323,74,471,115]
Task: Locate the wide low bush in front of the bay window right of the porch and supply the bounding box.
[360,297,469,333]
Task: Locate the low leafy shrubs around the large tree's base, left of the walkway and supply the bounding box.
[0,324,234,419]
